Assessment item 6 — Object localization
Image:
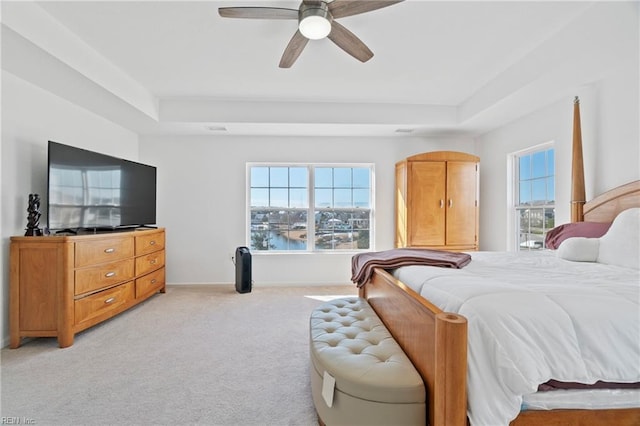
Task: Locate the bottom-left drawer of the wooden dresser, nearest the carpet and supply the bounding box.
[74,281,134,325]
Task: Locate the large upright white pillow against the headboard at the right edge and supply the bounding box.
[597,208,640,269]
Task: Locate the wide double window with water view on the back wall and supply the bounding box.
[248,164,373,252]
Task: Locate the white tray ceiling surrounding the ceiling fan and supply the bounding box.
[2,0,632,136]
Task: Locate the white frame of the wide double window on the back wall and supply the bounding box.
[245,161,375,255]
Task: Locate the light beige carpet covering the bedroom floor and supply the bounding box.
[0,285,356,426]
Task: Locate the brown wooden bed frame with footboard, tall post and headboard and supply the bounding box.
[360,101,640,426]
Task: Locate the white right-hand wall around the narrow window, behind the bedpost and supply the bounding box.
[477,62,640,251]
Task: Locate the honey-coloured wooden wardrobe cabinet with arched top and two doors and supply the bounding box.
[395,151,480,251]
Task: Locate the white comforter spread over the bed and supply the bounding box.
[394,251,640,426]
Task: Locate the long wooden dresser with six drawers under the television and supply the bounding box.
[9,229,165,348]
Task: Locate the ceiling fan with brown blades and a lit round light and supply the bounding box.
[218,0,403,68]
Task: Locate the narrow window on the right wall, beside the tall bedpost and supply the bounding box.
[514,145,555,250]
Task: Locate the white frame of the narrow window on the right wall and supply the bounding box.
[508,141,558,251]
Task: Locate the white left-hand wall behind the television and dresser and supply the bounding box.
[0,71,138,346]
